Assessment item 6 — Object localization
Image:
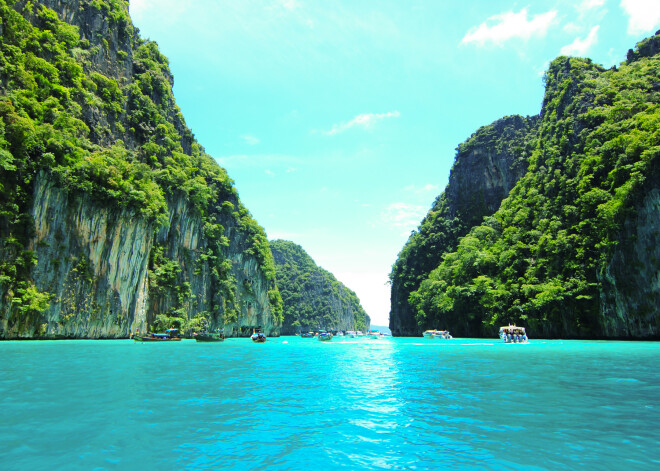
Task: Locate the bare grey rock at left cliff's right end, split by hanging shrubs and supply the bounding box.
[148,194,280,336]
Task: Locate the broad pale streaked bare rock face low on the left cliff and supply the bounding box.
[18,172,153,338]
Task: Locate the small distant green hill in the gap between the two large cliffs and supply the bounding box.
[270,240,370,334]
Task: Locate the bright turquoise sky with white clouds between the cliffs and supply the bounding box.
[130,0,660,325]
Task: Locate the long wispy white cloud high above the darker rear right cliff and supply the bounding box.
[461,8,557,45]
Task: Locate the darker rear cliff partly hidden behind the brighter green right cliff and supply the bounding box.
[390,116,539,336]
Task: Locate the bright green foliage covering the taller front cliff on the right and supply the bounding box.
[393,35,660,337]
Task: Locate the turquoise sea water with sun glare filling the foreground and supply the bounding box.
[0,337,660,471]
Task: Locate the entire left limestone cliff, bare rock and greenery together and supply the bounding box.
[0,0,282,338]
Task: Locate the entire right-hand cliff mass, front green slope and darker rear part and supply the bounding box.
[398,32,660,339]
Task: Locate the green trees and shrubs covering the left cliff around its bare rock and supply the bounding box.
[0,0,281,340]
